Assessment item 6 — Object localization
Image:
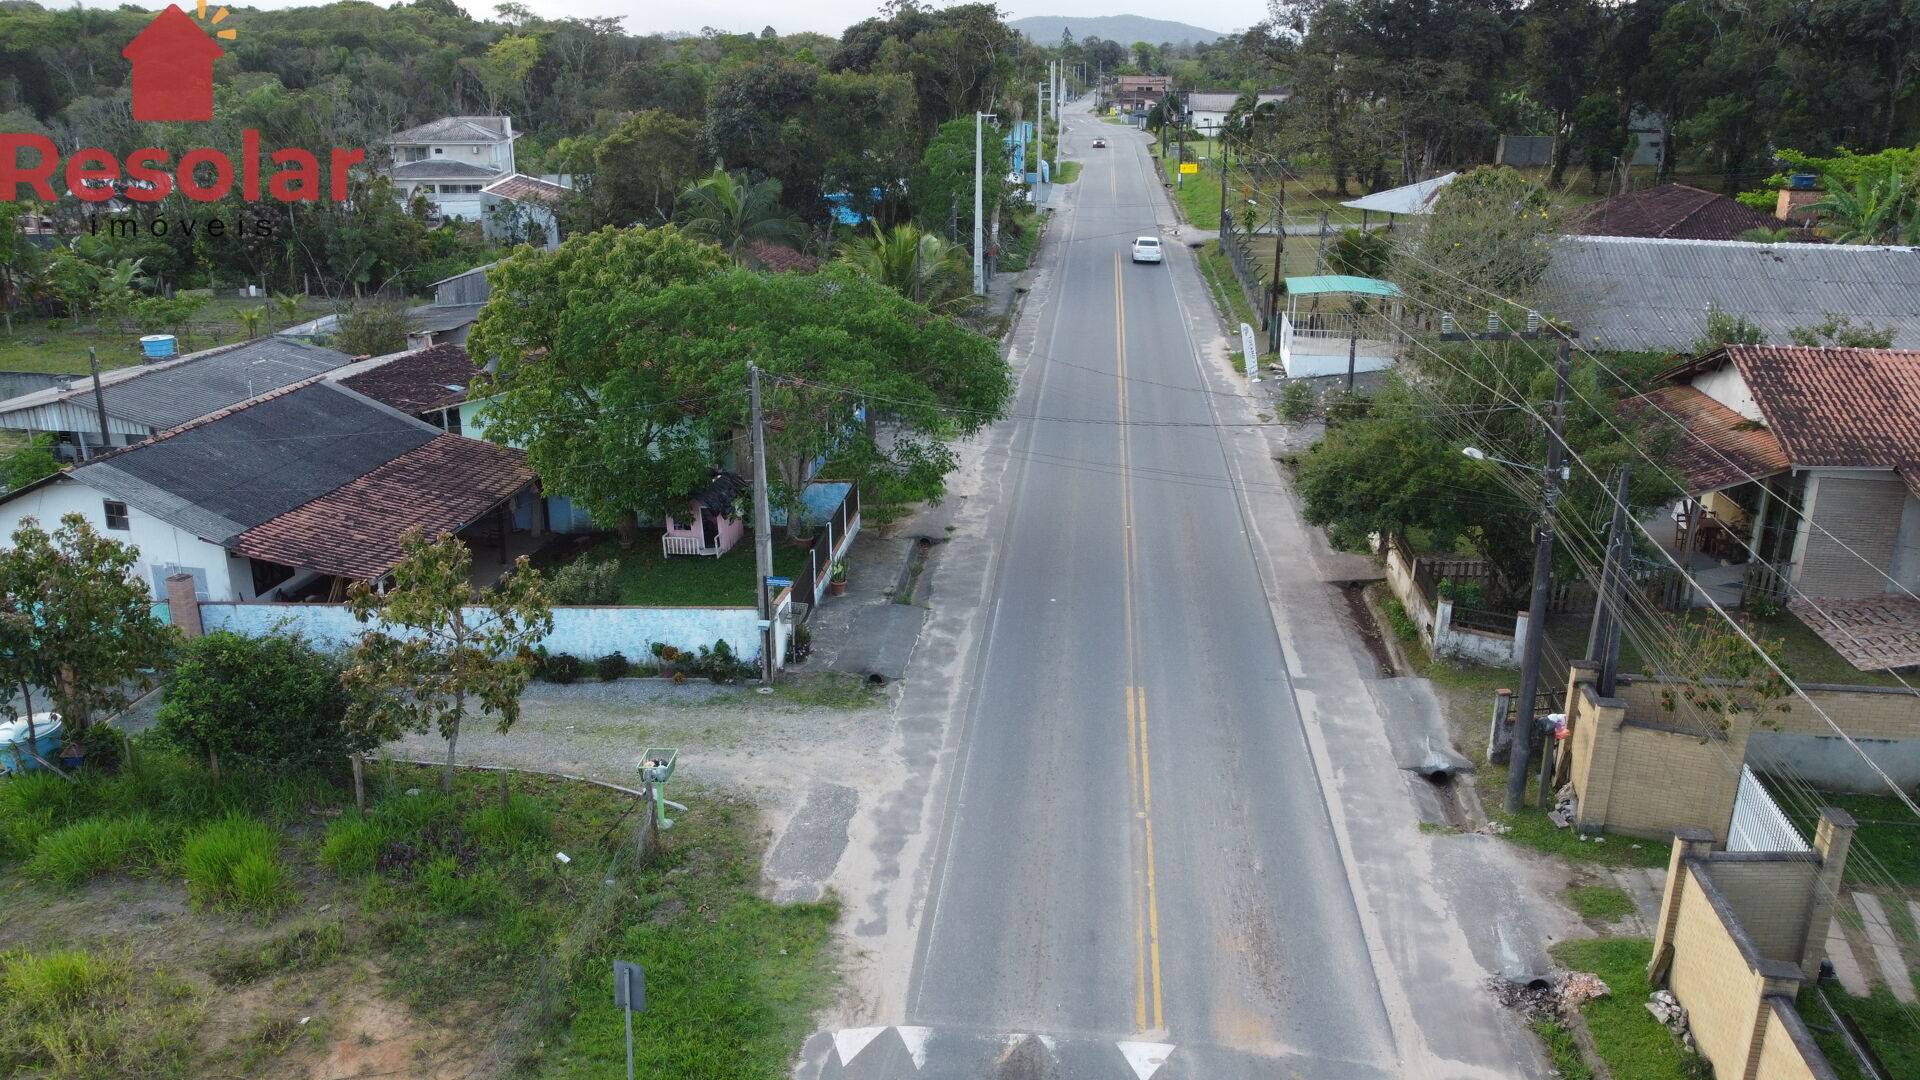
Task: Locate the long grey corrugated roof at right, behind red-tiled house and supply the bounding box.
[1540,236,1920,350]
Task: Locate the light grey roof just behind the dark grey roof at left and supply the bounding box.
[95,338,353,430]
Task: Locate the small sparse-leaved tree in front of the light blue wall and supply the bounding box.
[342,530,553,794]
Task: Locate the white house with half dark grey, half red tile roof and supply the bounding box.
[0,379,540,601]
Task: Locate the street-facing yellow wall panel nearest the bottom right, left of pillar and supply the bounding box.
[1667,865,1761,1076]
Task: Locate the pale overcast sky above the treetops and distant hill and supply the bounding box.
[86,0,1267,37]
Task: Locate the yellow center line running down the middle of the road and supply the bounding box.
[1114,252,1167,1032]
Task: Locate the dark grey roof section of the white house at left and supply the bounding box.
[73,382,440,546]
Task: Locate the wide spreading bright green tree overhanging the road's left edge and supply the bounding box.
[632,271,1012,532]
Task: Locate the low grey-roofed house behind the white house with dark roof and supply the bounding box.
[0,336,353,461]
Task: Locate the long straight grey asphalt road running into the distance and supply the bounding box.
[822,115,1396,1080]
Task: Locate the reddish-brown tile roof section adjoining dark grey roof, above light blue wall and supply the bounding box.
[232,434,534,580]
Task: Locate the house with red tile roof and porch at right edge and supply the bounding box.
[1620,346,1920,671]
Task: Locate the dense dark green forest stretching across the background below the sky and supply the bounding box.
[0,0,1920,309]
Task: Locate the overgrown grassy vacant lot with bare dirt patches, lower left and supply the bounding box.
[0,738,837,1080]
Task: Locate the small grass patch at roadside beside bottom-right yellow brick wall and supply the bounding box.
[1551,938,1701,1080]
